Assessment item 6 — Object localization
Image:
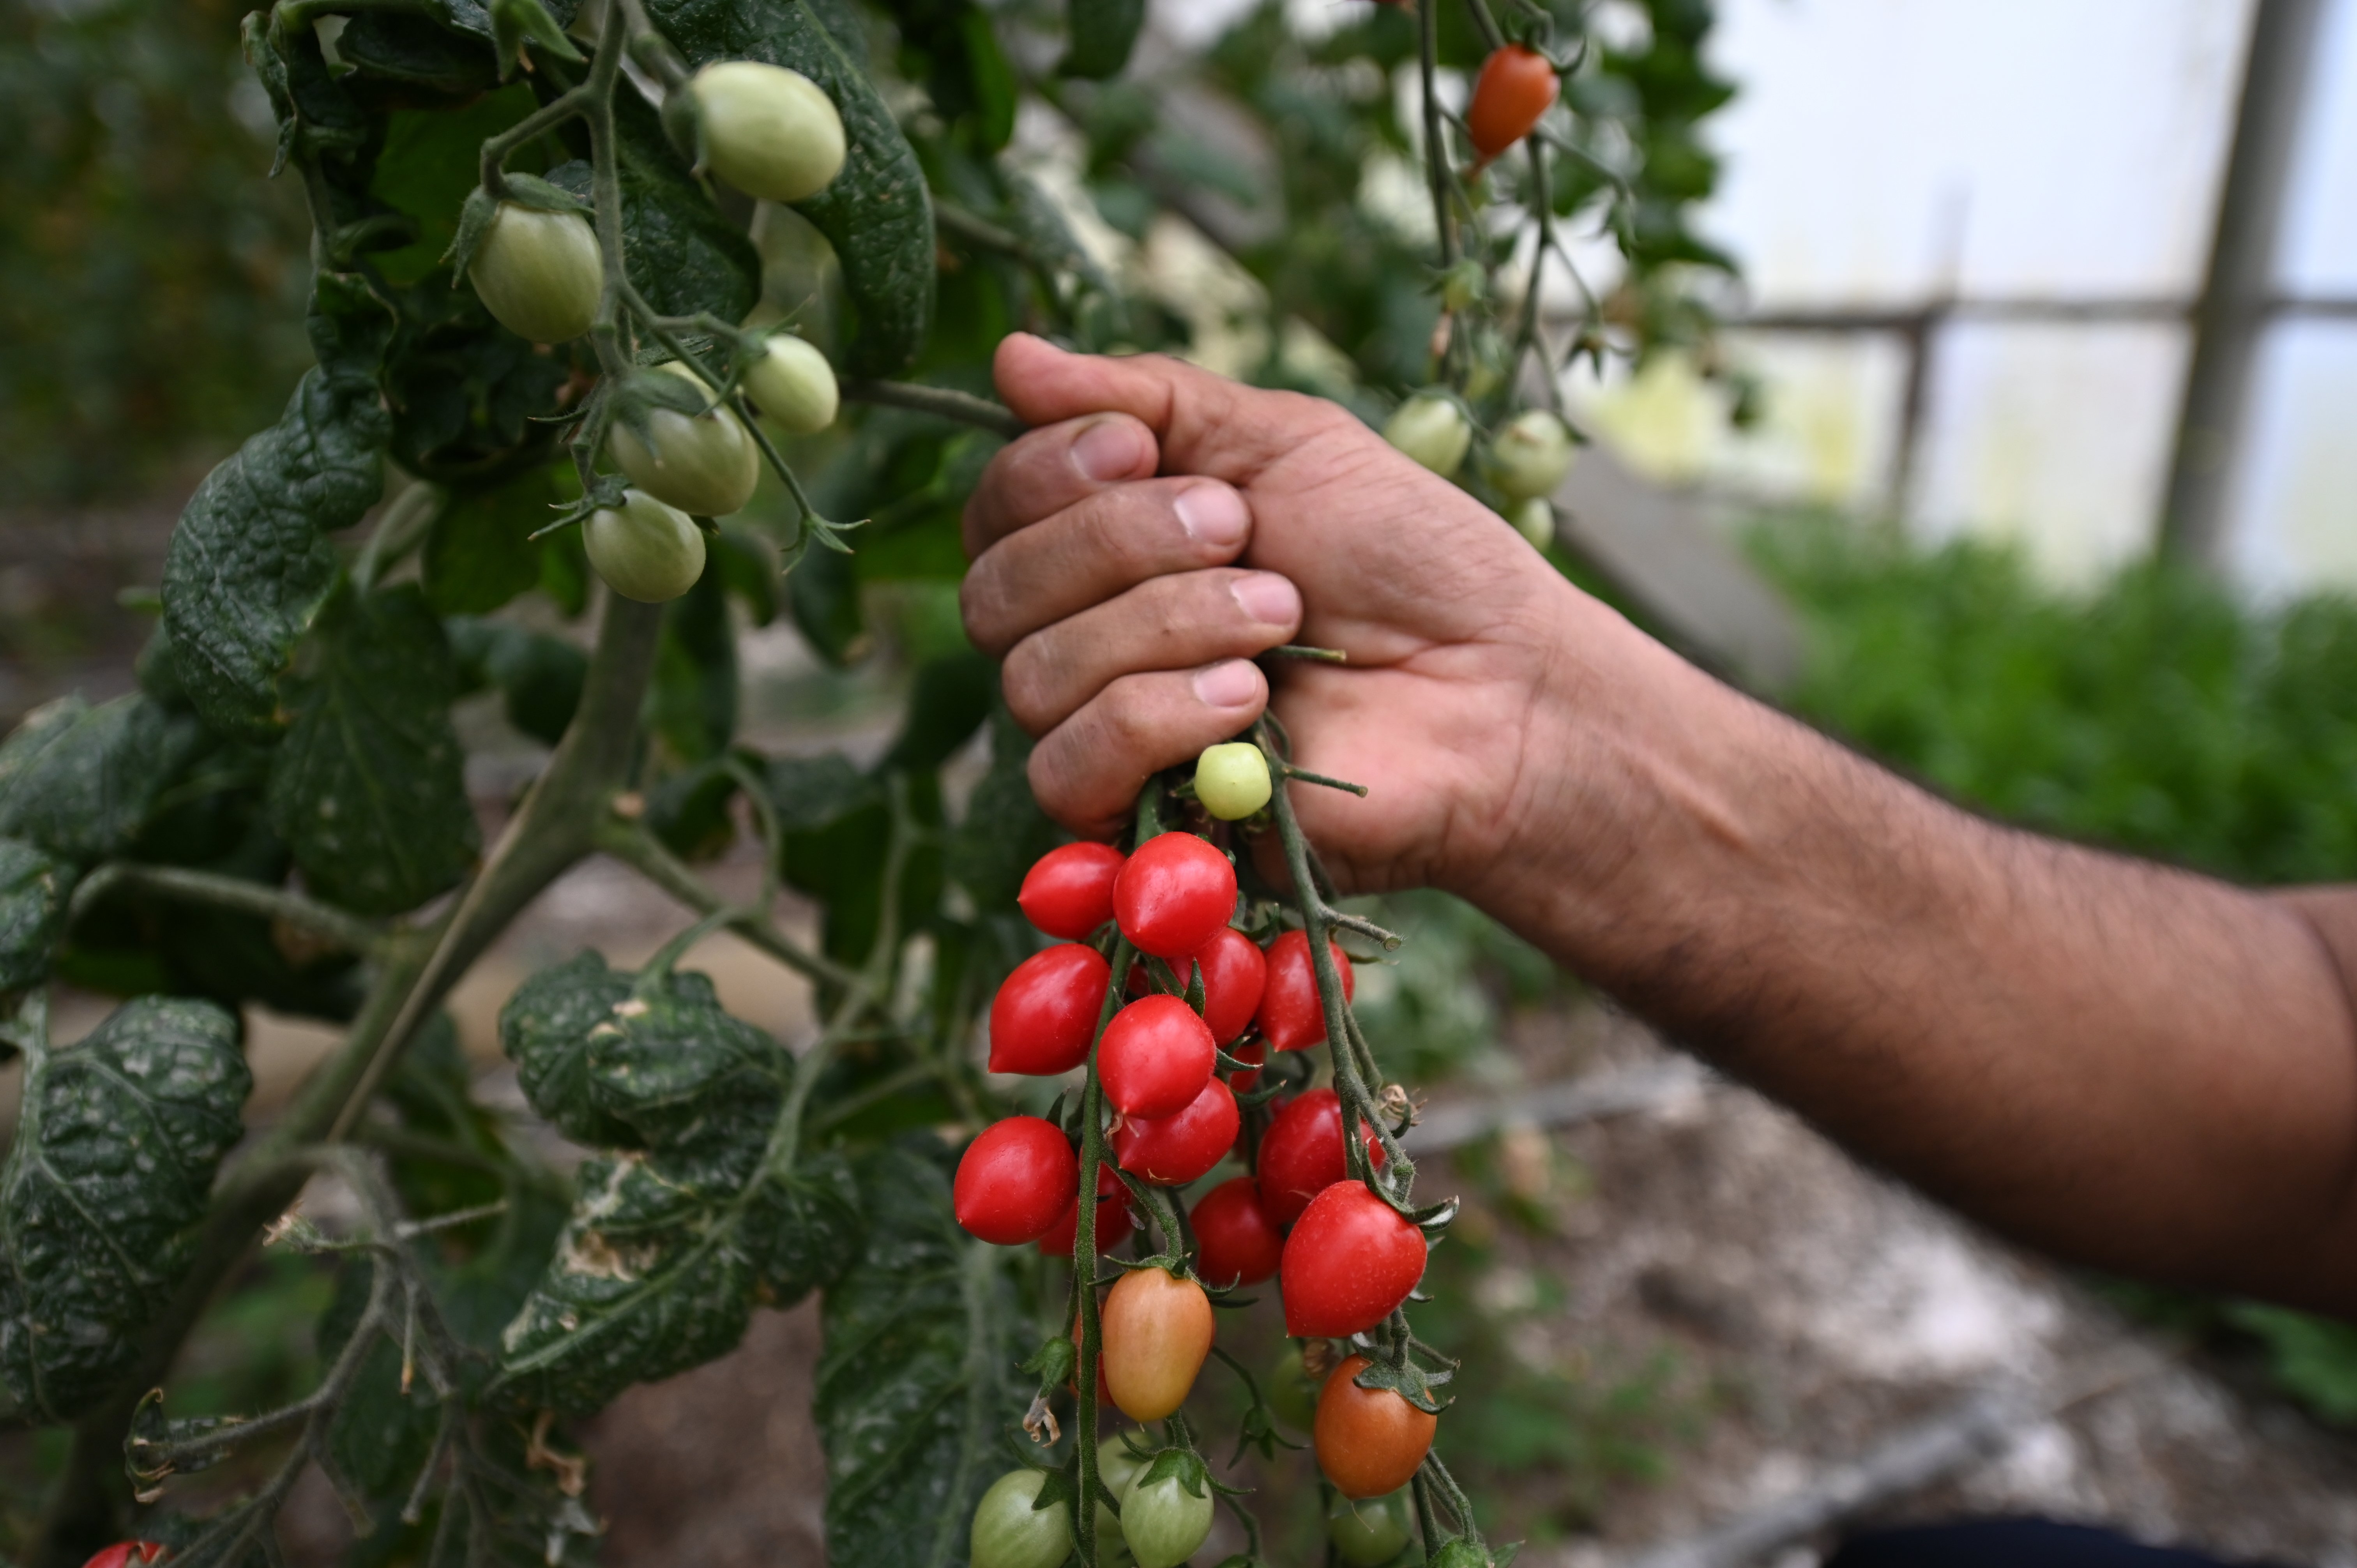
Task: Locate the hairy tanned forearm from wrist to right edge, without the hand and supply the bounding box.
[1466,599,2357,1308]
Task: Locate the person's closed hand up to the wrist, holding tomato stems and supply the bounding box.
[964,335,1633,891]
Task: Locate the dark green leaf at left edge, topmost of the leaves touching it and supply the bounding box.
[0,693,203,865]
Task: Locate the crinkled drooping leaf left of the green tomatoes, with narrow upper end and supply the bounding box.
[163,274,391,740]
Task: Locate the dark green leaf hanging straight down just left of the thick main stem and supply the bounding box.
[269,585,481,915]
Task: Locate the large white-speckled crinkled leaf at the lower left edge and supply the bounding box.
[0,998,252,1422]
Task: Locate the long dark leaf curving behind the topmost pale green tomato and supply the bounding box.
[646,0,933,375]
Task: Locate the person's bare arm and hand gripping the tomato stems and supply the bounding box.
[964,337,2357,1313]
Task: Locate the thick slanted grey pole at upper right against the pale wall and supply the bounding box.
[2159,0,2324,566]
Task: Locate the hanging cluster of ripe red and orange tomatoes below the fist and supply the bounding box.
[954,832,1433,1497]
